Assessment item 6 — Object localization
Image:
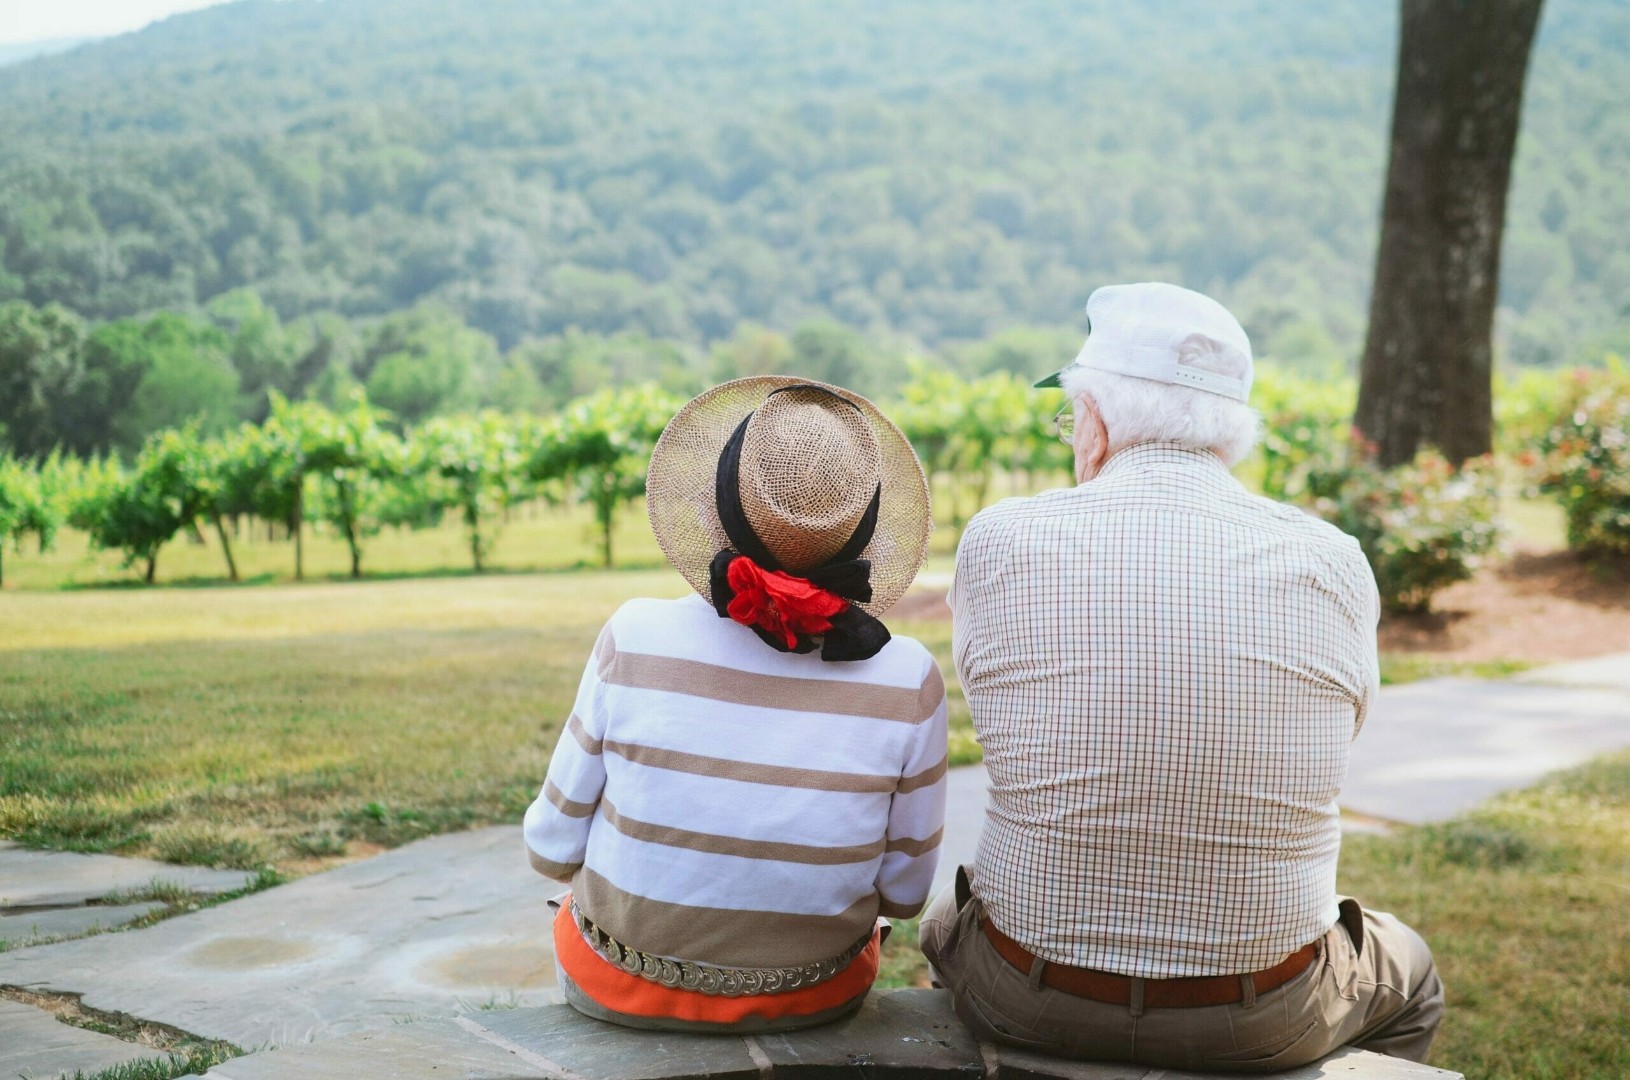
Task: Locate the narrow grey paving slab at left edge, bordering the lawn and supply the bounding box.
[0,842,254,911]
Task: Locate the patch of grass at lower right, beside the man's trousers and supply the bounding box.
[1340,754,1630,1080]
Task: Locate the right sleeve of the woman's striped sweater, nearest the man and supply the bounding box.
[877,656,947,919]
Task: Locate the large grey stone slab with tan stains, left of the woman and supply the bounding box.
[0,826,559,1046]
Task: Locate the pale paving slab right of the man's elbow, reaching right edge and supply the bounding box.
[1341,679,1630,824]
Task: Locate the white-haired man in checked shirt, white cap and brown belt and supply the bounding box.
[921,283,1443,1072]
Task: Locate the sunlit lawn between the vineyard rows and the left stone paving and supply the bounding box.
[0,570,976,868]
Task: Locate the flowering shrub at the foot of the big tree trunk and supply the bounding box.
[1306,432,1500,612]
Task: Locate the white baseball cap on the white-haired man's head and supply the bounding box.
[1037,282,1252,401]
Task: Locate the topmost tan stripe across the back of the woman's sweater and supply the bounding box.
[603,653,939,723]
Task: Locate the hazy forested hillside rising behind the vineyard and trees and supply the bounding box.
[0,0,1630,365]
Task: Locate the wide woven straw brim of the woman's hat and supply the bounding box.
[645,375,934,616]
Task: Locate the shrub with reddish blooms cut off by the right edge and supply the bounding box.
[1526,357,1630,555]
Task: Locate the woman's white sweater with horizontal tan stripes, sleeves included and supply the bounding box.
[525,595,945,968]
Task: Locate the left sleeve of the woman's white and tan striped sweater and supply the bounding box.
[522,624,616,881]
